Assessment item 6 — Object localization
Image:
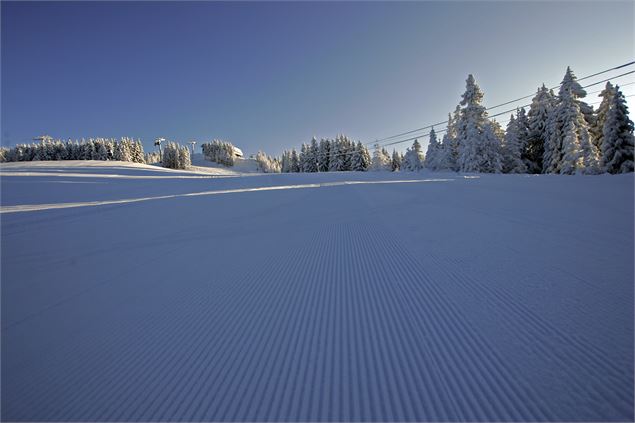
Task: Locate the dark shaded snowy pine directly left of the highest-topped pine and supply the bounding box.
[522,84,555,173]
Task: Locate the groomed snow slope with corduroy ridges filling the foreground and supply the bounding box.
[0,162,634,421]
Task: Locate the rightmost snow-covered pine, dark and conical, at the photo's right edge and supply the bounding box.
[602,86,635,173]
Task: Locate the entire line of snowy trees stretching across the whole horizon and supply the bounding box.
[0,68,635,174]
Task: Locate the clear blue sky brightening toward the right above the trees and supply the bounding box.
[0,1,635,154]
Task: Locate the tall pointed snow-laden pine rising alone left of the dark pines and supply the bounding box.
[456,74,488,172]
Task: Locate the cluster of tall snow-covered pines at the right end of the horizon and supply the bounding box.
[424,68,634,175]
